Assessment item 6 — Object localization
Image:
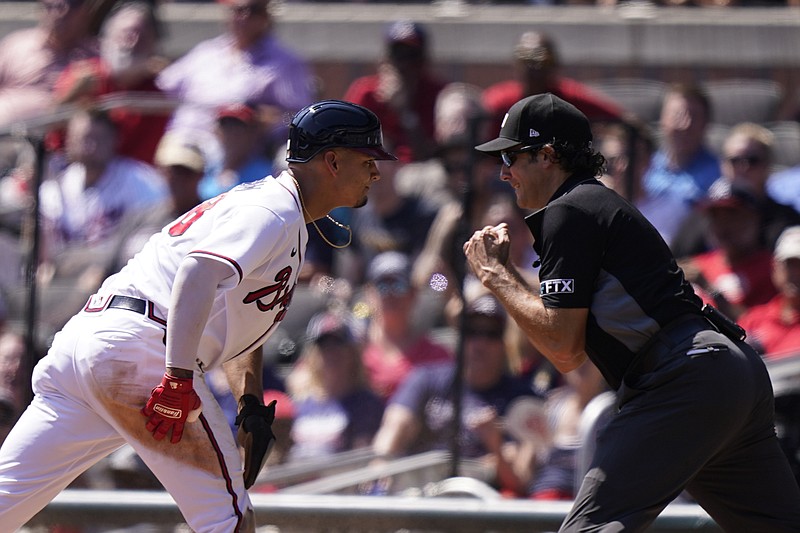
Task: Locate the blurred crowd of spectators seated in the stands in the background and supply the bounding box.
[0,0,800,520]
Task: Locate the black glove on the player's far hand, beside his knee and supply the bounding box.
[236,394,277,489]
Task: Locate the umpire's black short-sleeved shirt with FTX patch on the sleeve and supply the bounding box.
[526,175,701,389]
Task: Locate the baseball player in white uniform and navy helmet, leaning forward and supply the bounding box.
[0,100,395,533]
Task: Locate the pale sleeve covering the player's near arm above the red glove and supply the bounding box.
[166,257,228,377]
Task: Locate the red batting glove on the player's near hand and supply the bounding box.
[142,374,202,444]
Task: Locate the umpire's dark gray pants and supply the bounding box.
[560,318,800,533]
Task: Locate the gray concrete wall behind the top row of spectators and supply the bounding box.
[0,0,800,96]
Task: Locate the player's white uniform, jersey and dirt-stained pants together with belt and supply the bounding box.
[0,172,308,533]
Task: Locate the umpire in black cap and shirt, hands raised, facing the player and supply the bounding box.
[464,93,800,533]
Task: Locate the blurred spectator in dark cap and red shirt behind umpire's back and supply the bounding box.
[680,178,777,319]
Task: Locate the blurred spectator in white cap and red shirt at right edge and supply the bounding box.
[739,226,800,359]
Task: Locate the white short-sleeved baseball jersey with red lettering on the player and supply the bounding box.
[99,172,308,370]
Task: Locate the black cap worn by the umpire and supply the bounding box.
[475,93,592,157]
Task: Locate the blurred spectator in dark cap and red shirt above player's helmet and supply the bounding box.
[344,20,445,163]
